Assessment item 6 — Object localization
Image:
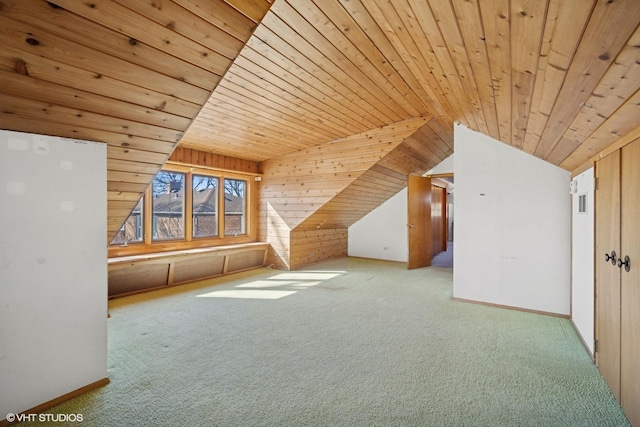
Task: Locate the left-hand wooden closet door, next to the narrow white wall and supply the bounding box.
[595,151,620,400]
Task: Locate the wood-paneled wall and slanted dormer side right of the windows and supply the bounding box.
[258,118,453,268]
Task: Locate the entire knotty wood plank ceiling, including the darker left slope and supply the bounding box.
[0,0,640,241]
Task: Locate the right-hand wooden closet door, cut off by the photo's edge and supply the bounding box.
[619,140,640,426]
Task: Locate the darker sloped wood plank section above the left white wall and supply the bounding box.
[0,0,272,240]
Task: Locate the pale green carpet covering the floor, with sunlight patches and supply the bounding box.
[21,258,629,427]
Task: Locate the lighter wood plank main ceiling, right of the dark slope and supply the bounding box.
[183,0,640,176]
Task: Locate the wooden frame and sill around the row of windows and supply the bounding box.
[108,162,260,257]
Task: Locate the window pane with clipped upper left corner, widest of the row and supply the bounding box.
[151,171,184,240]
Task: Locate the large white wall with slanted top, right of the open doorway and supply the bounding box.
[453,124,571,315]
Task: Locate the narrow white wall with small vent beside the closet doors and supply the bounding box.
[571,168,595,355]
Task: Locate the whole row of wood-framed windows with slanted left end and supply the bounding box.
[111,169,249,251]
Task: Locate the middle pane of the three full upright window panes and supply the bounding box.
[191,175,218,237]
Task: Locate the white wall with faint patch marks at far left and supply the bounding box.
[0,131,107,419]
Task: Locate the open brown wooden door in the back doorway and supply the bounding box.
[407,175,432,270]
